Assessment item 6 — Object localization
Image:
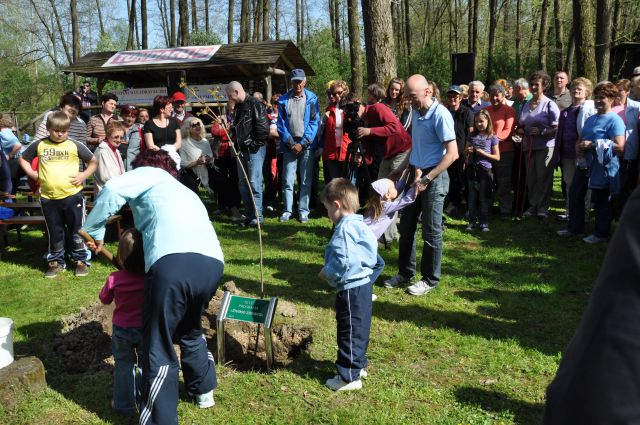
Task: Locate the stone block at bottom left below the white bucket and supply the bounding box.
[0,357,47,409]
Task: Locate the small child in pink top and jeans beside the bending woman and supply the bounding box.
[100,229,145,415]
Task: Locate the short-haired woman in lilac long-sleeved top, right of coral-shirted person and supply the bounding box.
[517,71,560,218]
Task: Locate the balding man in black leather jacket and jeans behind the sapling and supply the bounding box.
[226,81,269,227]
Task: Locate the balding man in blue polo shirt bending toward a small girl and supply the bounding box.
[384,74,458,295]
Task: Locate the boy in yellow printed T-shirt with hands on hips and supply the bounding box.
[20,111,98,278]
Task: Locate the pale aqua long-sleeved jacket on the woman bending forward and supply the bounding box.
[82,167,224,271]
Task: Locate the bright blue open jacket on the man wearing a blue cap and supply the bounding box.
[276,89,320,152]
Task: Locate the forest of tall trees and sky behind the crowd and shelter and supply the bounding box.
[0,0,640,122]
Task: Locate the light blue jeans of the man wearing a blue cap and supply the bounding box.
[282,149,315,217]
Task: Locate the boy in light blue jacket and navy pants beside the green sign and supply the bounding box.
[319,178,382,391]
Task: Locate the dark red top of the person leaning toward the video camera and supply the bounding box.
[364,102,411,163]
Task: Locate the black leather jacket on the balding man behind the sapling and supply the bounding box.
[231,94,269,153]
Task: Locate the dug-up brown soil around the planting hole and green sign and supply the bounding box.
[49,282,313,373]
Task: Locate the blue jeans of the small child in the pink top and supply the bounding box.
[111,325,142,415]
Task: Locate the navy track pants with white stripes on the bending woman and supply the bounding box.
[140,253,224,425]
